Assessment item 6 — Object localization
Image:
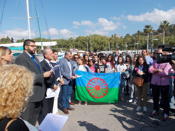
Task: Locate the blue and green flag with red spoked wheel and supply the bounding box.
[75,71,120,103]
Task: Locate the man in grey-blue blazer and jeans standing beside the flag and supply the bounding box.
[58,52,76,114]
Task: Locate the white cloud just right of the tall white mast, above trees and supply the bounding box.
[43,28,76,38]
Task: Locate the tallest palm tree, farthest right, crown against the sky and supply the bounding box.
[159,20,170,45]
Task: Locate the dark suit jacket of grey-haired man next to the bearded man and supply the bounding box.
[41,59,56,89]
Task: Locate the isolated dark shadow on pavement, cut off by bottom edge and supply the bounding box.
[78,121,109,131]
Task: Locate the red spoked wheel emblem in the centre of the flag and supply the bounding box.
[86,78,108,98]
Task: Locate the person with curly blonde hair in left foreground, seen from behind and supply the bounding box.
[0,64,36,131]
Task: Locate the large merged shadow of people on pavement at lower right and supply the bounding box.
[109,102,175,131]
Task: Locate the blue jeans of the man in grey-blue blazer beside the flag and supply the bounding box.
[58,84,72,110]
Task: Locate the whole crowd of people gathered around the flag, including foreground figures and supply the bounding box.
[0,39,175,131]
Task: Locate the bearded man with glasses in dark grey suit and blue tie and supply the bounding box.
[15,39,52,125]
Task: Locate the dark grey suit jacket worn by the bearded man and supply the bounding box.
[15,52,45,102]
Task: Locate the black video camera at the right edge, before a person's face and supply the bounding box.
[156,46,175,63]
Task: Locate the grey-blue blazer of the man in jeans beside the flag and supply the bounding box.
[59,58,74,85]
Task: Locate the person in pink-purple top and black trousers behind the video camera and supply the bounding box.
[149,47,172,120]
